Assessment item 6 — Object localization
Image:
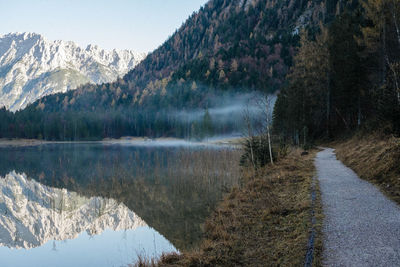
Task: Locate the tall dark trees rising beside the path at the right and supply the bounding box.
[274,0,400,145]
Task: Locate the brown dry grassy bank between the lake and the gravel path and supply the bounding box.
[138,151,322,266]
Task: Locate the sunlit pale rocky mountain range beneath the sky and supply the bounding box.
[0,33,146,111]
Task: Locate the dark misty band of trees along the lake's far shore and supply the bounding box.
[0,89,250,141]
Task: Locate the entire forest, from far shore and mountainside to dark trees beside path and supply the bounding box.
[0,0,400,144]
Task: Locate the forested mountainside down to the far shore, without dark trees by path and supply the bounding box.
[2,0,341,140]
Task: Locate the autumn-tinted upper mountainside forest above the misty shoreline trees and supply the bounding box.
[24,0,332,112]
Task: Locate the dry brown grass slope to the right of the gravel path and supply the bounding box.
[333,135,400,203]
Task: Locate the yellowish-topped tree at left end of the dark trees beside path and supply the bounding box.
[274,29,330,145]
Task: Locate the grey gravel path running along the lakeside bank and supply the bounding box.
[315,149,400,266]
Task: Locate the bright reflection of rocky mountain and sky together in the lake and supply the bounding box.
[0,171,176,266]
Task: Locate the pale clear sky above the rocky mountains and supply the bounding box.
[0,0,207,52]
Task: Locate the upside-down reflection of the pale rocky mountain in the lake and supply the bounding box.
[0,171,147,249]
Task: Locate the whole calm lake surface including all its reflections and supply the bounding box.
[0,142,240,266]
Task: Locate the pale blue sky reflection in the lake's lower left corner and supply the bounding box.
[0,226,175,267]
